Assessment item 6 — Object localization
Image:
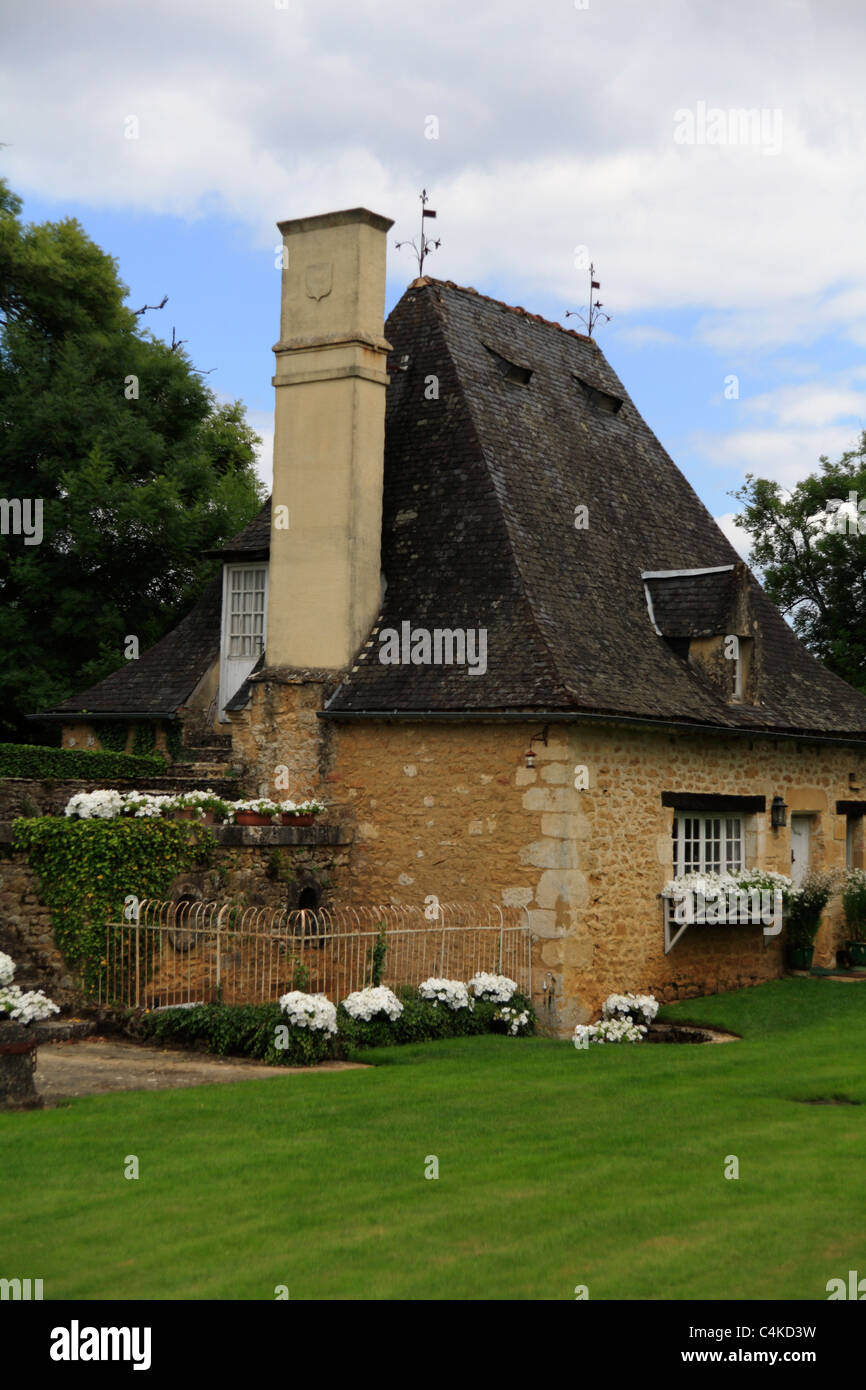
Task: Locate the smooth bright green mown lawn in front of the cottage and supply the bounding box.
[0,979,866,1300]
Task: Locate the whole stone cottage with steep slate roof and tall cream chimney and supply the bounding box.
[40,209,866,1030]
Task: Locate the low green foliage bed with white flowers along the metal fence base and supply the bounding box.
[126,988,535,1066]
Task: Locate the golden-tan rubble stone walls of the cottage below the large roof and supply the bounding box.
[322,721,866,1031]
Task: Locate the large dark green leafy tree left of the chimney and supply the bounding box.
[0,179,263,741]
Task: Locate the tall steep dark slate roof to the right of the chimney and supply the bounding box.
[327,278,866,738]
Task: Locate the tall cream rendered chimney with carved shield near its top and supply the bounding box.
[265,207,393,670]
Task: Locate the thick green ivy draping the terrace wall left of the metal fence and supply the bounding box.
[13,816,214,991]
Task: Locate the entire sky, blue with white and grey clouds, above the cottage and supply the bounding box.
[0,0,866,543]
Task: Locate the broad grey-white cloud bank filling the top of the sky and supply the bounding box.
[0,0,866,344]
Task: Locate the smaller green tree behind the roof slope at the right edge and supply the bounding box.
[734,432,866,689]
